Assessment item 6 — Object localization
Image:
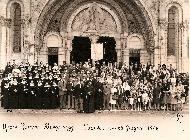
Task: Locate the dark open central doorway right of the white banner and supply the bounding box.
[97,37,117,64]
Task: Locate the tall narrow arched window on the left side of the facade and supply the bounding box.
[11,2,21,53]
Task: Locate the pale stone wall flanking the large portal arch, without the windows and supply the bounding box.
[0,0,189,72]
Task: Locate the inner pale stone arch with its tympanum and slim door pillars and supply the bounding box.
[61,2,122,62]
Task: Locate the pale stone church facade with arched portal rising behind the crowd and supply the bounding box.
[0,0,189,72]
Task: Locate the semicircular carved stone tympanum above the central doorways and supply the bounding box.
[67,2,121,34]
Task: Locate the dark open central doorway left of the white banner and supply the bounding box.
[71,36,91,63]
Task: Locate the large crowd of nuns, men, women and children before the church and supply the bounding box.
[1,60,189,113]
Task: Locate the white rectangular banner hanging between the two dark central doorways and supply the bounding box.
[91,43,104,61]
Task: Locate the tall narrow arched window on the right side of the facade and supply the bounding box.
[167,6,179,56]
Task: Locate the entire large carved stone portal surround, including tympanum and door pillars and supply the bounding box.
[35,0,154,63]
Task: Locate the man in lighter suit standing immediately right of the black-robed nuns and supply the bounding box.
[58,77,67,110]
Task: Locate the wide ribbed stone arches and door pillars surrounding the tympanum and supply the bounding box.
[35,0,154,65]
